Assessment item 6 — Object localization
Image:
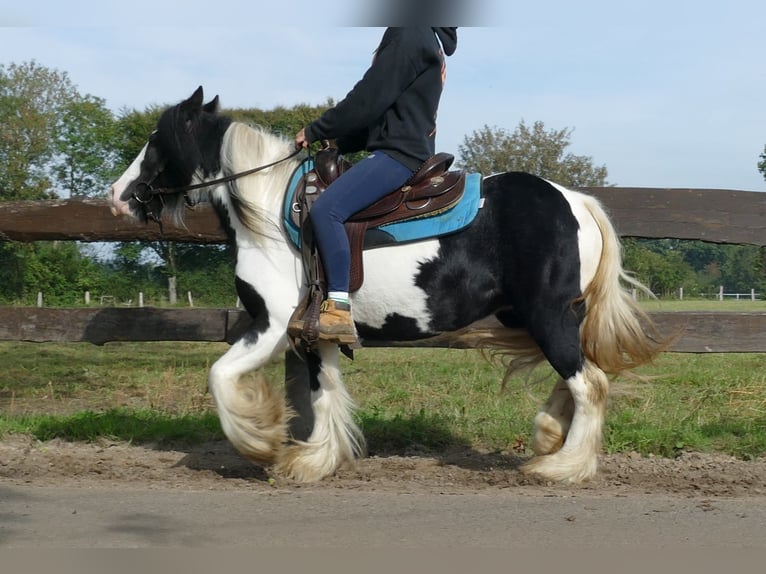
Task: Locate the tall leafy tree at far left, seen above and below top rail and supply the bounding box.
[0,61,137,303]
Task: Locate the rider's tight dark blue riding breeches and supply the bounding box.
[309,151,413,292]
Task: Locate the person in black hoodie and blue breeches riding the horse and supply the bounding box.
[295,26,457,343]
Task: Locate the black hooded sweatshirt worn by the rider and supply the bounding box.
[305,26,457,171]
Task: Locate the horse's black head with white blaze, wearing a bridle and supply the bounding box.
[109,86,228,222]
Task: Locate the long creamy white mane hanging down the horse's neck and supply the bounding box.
[221,122,301,243]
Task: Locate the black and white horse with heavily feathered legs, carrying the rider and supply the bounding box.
[108,86,663,484]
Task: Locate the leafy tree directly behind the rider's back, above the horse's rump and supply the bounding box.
[458,120,607,187]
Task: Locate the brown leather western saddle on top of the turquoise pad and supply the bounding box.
[291,147,465,293]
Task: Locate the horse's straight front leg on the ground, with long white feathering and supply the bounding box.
[276,343,365,482]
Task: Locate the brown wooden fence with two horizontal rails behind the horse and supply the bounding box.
[0,187,766,353]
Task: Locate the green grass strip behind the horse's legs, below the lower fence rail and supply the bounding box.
[0,342,766,464]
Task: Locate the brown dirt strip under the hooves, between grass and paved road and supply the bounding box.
[0,435,766,498]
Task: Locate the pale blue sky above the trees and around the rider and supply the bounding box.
[0,0,766,191]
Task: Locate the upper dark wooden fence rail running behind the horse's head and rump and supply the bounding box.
[0,187,766,246]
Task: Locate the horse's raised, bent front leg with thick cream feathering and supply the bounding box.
[208,329,291,472]
